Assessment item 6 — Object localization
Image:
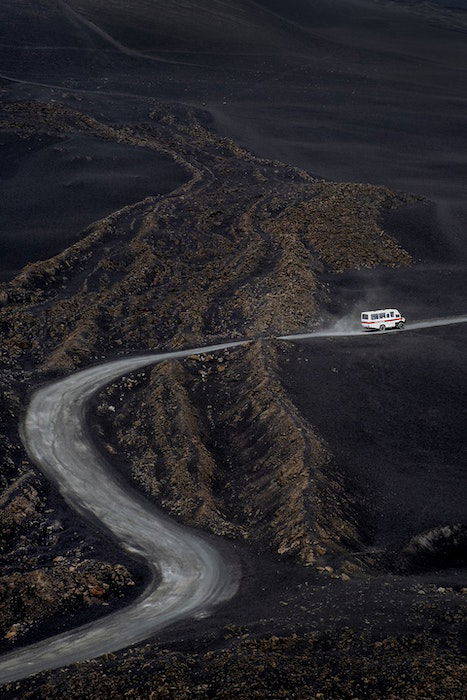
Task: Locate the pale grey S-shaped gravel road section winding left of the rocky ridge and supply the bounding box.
[0,341,248,683]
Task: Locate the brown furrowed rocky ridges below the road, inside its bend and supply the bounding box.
[93,342,358,564]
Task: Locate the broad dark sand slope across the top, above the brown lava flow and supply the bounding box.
[0,0,467,259]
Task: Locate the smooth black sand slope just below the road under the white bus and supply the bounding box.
[282,324,467,556]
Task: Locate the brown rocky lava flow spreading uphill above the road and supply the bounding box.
[0,102,415,370]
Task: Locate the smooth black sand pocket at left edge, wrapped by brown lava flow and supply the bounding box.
[0,133,186,280]
